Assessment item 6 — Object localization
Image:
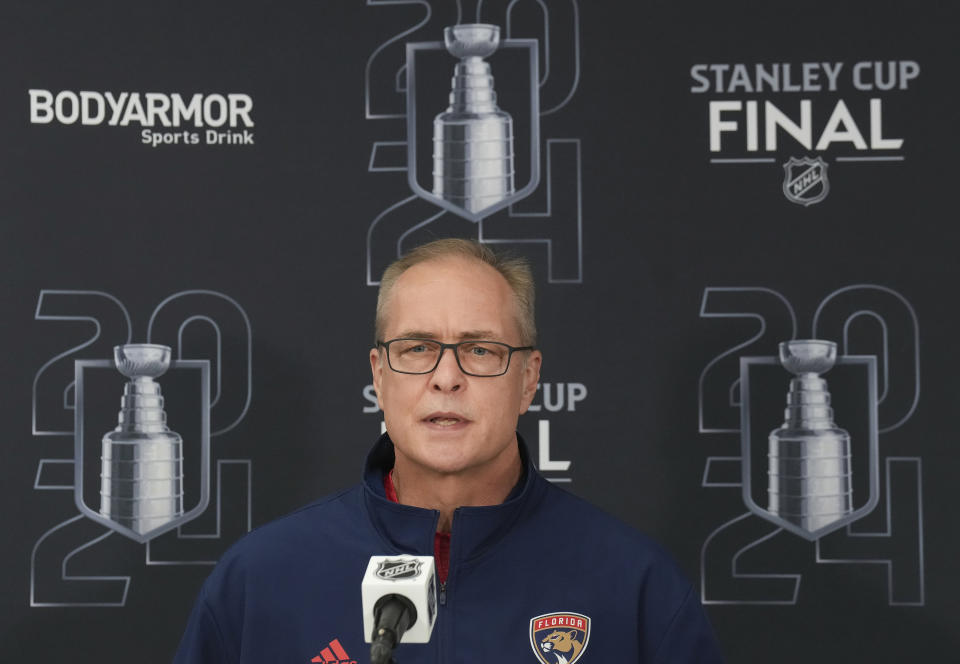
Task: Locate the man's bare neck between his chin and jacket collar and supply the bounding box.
[393,436,523,533]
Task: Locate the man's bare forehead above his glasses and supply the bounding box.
[385,258,519,342]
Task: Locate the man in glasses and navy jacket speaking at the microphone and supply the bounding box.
[176,240,721,664]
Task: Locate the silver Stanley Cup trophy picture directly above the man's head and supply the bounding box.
[433,23,514,213]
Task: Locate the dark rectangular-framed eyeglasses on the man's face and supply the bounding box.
[377,339,534,377]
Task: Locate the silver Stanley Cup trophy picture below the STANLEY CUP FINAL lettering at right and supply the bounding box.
[769,339,853,532]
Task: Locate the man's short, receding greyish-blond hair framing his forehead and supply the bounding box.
[374,238,537,346]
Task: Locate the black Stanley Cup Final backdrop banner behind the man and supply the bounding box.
[0,0,960,662]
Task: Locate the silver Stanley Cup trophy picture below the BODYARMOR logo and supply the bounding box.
[100,344,183,535]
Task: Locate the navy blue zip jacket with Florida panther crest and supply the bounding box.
[174,435,722,664]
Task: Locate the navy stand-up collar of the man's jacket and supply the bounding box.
[363,434,547,564]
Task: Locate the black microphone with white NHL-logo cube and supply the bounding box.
[360,555,437,664]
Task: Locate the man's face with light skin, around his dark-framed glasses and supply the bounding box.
[370,258,541,474]
